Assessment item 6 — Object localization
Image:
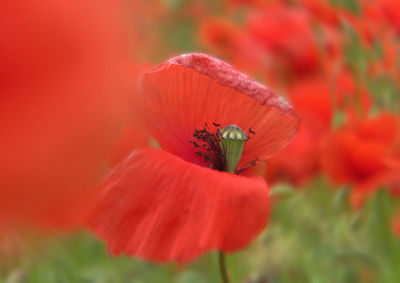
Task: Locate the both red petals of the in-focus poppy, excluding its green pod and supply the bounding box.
[90,54,298,262]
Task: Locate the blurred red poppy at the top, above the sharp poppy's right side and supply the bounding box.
[247,4,321,78]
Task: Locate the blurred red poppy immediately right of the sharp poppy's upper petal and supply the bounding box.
[266,78,333,186]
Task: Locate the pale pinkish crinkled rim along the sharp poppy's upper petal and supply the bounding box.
[148,53,299,120]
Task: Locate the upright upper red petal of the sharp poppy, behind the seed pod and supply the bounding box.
[139,54,298,168]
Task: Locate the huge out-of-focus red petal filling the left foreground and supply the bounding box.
[0,0,139,231]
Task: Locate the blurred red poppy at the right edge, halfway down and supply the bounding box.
[322,113,400,207]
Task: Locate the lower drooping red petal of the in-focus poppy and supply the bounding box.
[90,149,269,262]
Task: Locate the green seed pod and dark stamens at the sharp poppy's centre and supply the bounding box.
[189,123,255,174]
